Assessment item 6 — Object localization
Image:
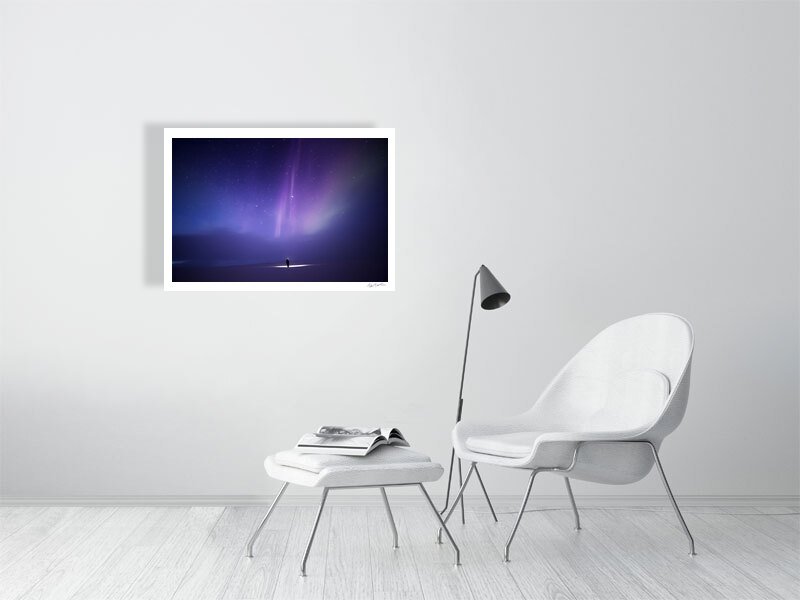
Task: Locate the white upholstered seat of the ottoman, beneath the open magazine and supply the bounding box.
[264,446,444,487]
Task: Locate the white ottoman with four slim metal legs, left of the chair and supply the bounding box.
[247,446,461,577]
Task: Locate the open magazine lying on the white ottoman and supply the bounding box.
[294,425,409,456]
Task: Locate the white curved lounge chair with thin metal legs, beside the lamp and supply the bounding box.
[439,313,695,561]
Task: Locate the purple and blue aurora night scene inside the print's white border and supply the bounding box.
[172,138,388,281]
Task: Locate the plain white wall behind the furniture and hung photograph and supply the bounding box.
[0,1,800,497]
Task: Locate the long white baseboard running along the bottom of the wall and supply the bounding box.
[0,490,800,508]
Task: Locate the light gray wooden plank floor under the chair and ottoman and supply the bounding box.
[0,504,800,600]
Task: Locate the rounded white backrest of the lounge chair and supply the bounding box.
[528,313,694,443]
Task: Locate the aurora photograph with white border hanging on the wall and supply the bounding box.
[164,128,395,292]
